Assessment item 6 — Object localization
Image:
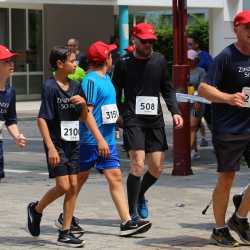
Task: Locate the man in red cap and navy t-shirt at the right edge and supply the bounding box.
[199,10,250,247]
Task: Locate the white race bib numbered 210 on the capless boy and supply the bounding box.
[61,121,79,141]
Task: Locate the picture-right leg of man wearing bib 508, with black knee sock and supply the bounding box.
[139,149,165,201]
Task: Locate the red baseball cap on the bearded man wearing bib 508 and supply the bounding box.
[132,23,157,40]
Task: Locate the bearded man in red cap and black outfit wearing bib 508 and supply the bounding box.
[113,23,183,221]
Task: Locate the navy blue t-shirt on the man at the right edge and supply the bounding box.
[204,44,250,134]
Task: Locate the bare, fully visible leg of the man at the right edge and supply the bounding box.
[213,172,235,228]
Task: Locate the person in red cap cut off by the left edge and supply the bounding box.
[0,45,26,182]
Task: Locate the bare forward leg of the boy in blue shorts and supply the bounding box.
[103,169,131,222]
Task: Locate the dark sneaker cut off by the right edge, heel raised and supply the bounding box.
[228,213,250,244]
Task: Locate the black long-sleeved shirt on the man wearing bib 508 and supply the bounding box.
[112,52,180,128]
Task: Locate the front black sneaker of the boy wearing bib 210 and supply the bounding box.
[57,230,85,248]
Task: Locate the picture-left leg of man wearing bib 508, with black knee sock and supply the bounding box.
[127,150,145,217]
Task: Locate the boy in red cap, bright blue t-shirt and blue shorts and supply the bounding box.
[71,41,151,236]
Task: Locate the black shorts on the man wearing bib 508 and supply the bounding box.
[123,127,168,153]
